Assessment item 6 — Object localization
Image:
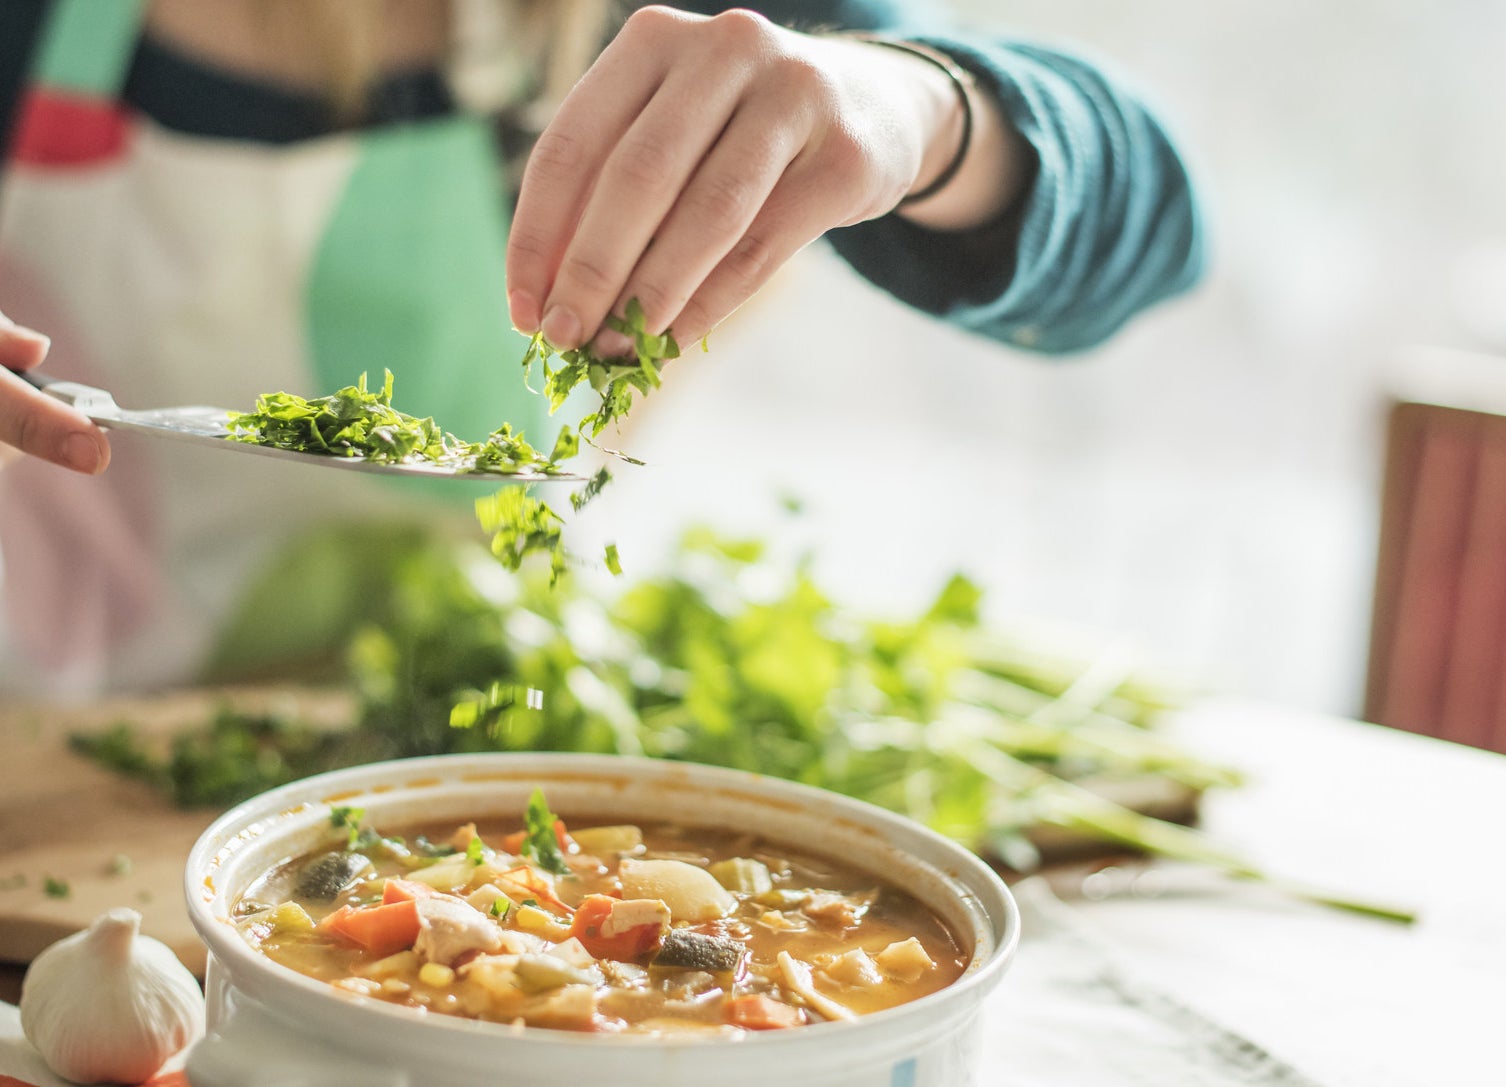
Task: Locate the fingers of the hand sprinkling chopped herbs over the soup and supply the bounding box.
[508,8,809,348]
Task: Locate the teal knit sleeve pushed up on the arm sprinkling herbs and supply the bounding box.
[827,36,1206,354]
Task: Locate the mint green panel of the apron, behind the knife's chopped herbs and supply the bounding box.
[307,114,545,449]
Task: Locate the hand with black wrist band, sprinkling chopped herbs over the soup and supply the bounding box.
[508,8,1023,354]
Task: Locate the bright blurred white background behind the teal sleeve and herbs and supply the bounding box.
[586,0,1506,714]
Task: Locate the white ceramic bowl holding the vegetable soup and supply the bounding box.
[185,754,1020,1087]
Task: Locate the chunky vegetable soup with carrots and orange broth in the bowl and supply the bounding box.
[235,792,967,1033]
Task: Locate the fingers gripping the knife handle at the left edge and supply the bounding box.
[0,313,110,476]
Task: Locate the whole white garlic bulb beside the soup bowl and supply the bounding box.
[21,909,203,1084]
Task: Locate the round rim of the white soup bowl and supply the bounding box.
[184,751,1020,1052]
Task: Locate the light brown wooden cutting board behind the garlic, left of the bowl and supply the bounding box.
[0,690,349,976]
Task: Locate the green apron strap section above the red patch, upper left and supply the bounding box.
[33,0,146,99]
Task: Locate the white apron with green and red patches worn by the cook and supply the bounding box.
[0,0,553,697]
